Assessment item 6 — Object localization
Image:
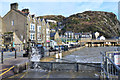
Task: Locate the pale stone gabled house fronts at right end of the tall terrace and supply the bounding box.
[37,17,50,47]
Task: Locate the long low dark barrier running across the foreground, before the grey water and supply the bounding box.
[31,62,100,72]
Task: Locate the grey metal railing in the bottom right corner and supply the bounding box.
[101,52,120,80]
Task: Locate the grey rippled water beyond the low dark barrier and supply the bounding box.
[62,47,118,63]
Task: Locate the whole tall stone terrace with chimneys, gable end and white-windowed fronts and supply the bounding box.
[3,3,50,49]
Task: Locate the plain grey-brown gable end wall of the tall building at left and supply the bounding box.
[3,10,27,41]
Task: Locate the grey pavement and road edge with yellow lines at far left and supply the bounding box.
[0,51,28,79]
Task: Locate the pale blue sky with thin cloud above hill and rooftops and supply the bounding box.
[0,0,118,17]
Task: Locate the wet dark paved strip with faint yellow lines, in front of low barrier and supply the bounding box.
[6,69,99,80]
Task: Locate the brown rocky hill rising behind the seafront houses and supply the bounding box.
[39,11,120,38]
